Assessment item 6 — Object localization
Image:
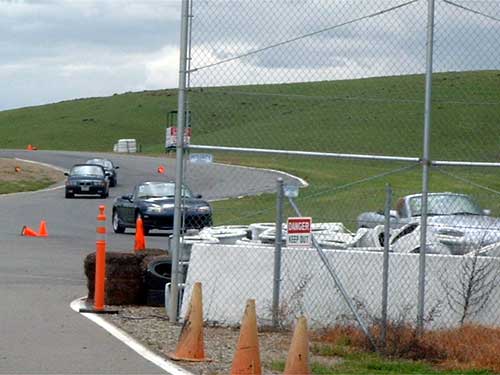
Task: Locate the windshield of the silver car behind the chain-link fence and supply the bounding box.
[410,194,482,216]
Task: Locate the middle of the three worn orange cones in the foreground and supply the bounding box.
[231,299,262,375]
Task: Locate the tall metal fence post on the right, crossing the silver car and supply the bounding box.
[417,0,434,332]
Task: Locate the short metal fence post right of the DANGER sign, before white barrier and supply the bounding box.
[380,184,392,350]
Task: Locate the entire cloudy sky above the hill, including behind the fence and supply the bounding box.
[0,0,500,110]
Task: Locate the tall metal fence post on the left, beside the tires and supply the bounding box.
[169,0,189,322]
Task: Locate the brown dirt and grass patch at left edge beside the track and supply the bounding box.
[0,158,64,193]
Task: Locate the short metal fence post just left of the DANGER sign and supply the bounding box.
[273,178,284,327]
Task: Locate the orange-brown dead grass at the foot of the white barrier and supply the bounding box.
[314,324,500,373]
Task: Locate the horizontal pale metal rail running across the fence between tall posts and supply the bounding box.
[188,145,500,167]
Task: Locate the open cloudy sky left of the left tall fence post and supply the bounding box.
[0,0,180,110]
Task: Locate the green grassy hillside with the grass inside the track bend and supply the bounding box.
[0,71,500,228]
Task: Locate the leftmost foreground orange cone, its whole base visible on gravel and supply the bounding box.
[167,282,209,362]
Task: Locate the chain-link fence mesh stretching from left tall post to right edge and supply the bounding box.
[169,0,500,342]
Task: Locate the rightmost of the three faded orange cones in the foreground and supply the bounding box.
[283,316,311,375]
